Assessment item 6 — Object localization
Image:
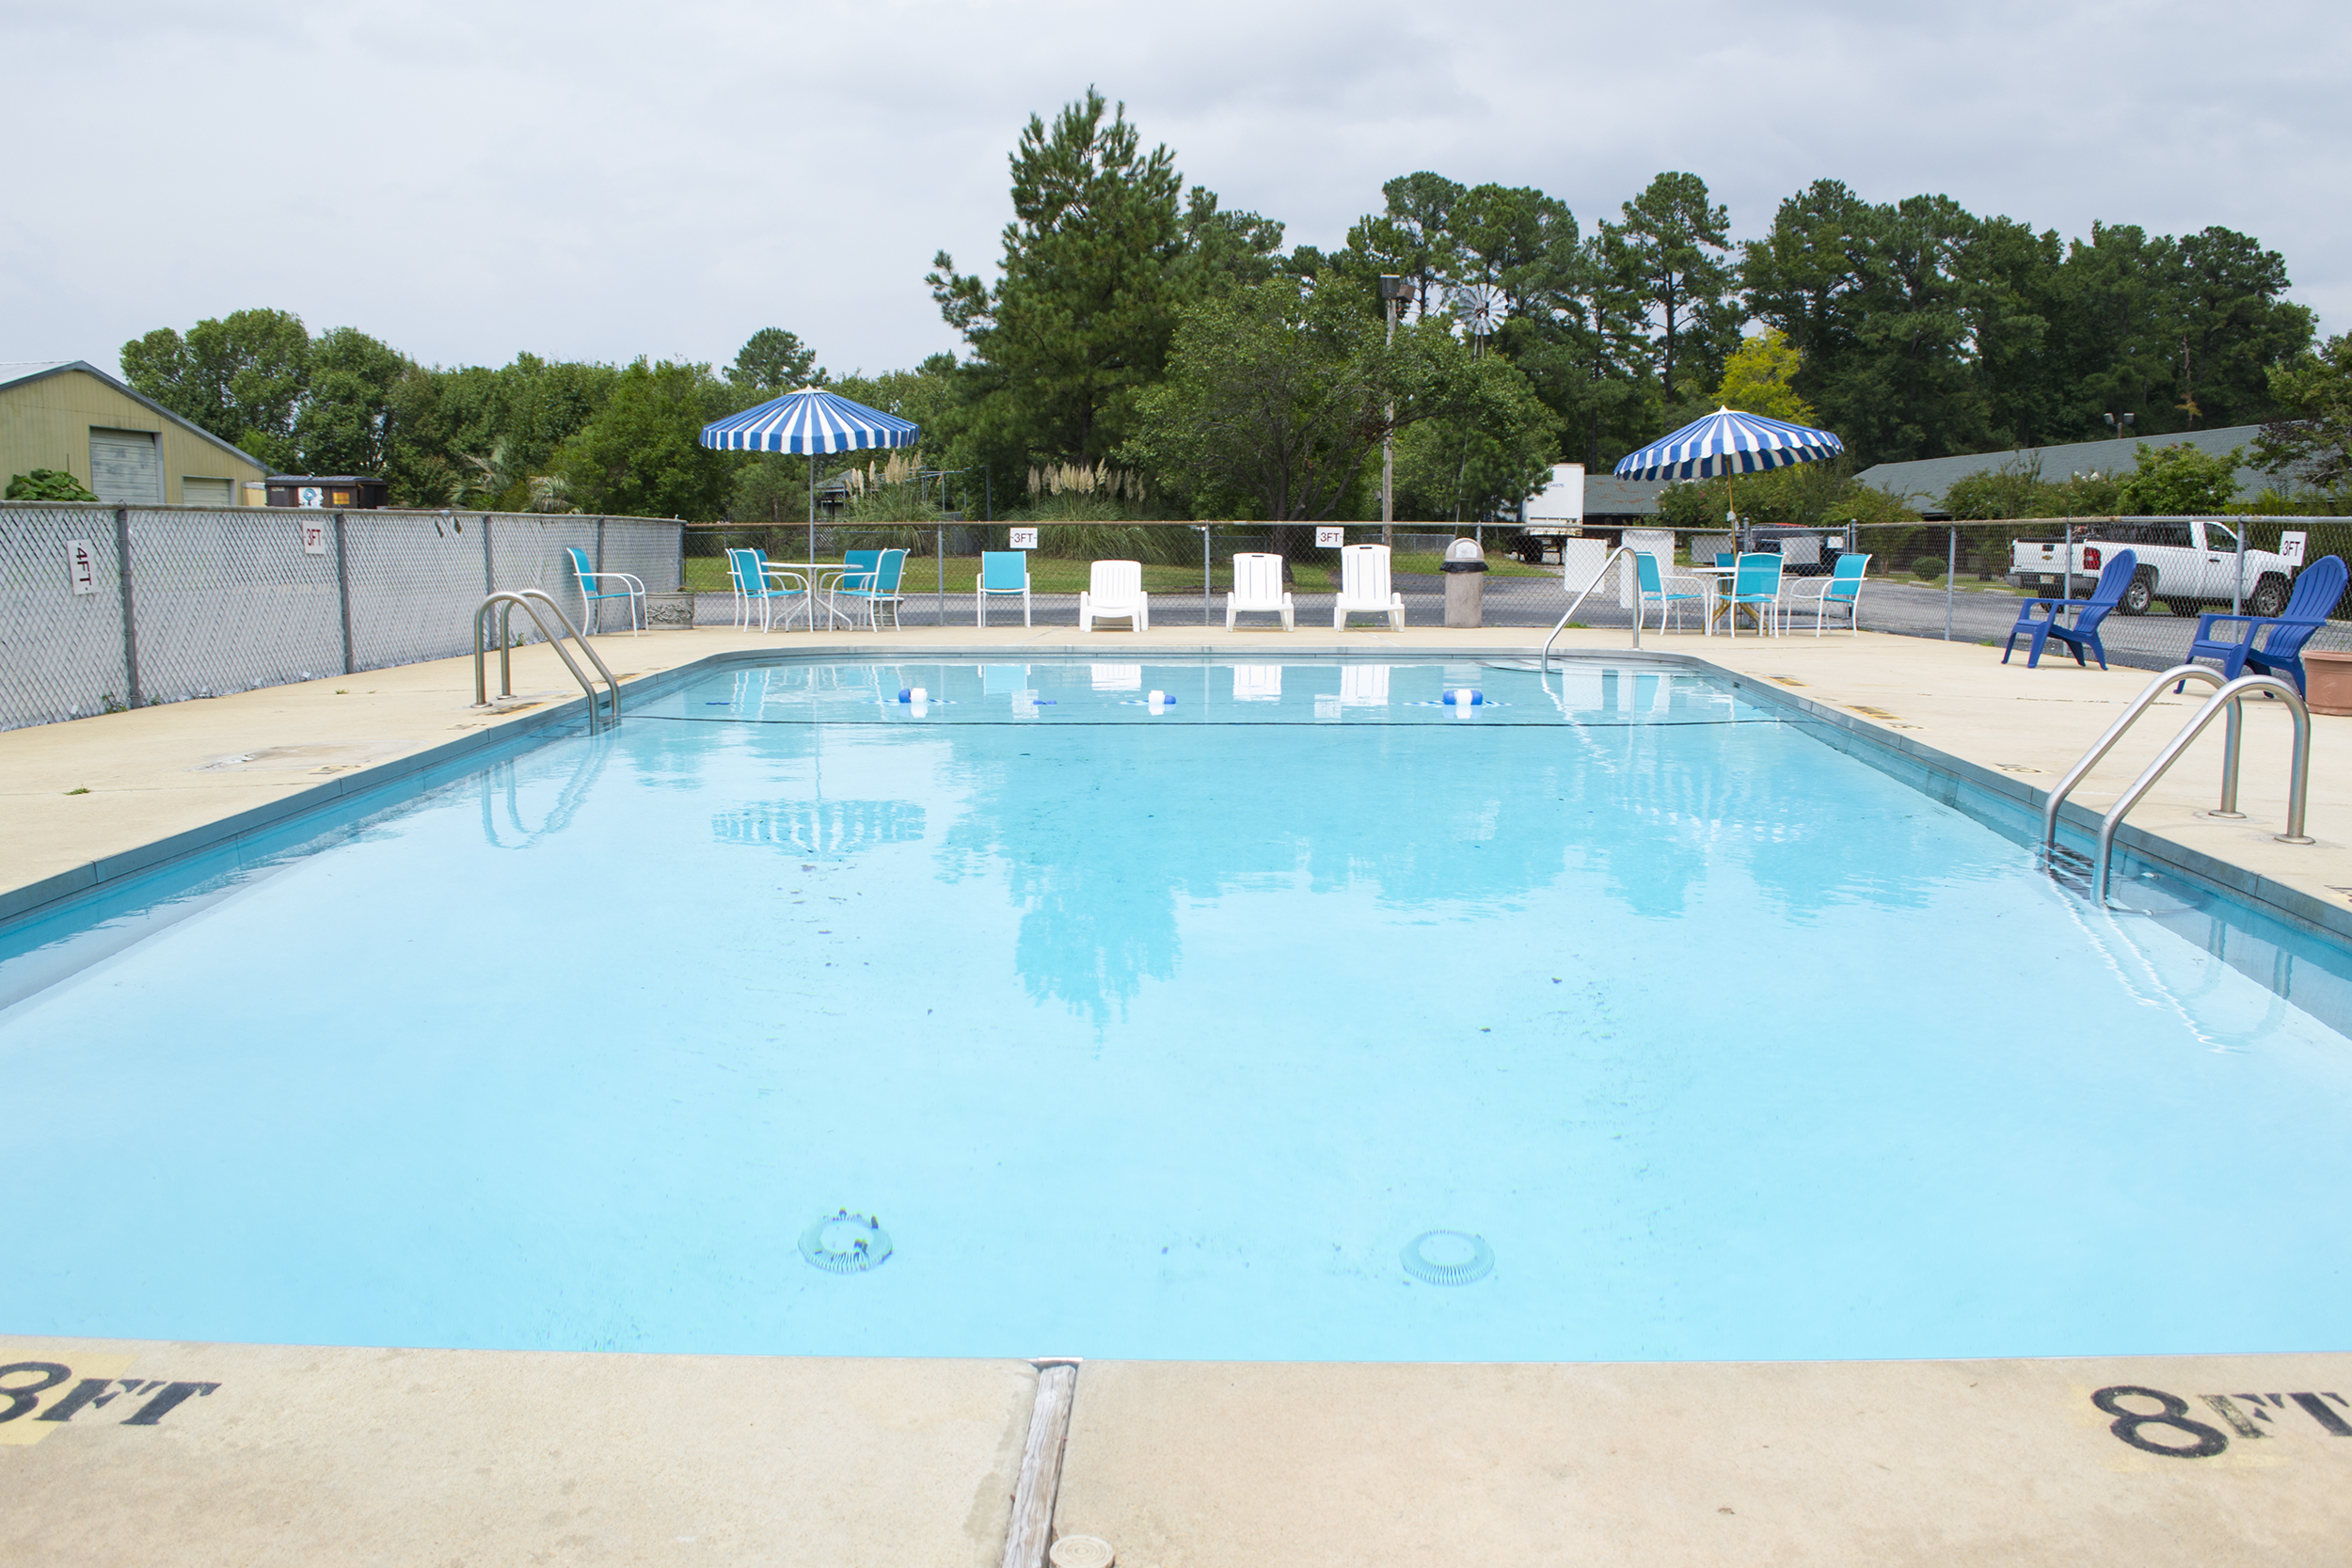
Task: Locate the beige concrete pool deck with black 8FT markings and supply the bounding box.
[13,626,2352,1568]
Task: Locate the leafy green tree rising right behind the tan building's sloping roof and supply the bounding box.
[122,310,310,470]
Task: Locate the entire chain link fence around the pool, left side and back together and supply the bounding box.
[13,503,2352,729]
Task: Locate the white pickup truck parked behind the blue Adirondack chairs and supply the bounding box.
[2009,517,2296,616]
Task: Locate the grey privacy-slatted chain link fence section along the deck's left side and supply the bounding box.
[0,503,682,729]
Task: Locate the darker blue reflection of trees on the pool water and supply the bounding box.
[934,700,1927,1027]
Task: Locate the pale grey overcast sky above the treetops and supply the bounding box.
[0,0,2352,372]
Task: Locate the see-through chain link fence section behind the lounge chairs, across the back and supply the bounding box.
[685,517,2352,670]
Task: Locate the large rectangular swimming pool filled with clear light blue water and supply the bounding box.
[0,660,2352,1361]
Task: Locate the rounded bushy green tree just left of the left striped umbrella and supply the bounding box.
[555,359,734,522]
